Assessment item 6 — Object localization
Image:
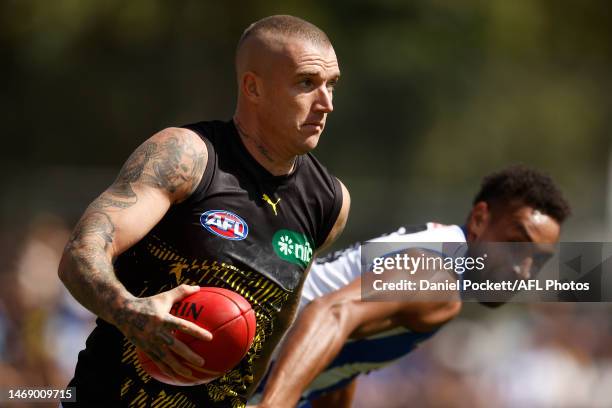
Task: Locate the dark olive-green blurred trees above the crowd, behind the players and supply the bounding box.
[0,0,612,244]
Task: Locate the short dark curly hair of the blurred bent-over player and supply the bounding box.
[474,165,571,223]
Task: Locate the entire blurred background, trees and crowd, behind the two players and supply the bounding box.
[0,0,612,408]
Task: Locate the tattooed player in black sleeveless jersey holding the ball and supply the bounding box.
[59,16,350,407]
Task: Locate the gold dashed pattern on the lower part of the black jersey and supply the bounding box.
[121,239,290,408]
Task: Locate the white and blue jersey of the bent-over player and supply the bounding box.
[252,223,466,407]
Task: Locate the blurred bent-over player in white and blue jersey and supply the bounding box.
[253,166,570,408]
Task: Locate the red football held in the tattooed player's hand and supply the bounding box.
[136,287,256,385]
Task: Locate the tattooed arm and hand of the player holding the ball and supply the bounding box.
[59,128,211,377]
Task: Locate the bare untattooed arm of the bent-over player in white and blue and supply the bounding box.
[253,268,460,408]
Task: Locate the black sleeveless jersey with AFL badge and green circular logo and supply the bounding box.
[65,121,342,408]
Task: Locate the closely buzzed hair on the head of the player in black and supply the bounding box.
[237,15,331,50]
